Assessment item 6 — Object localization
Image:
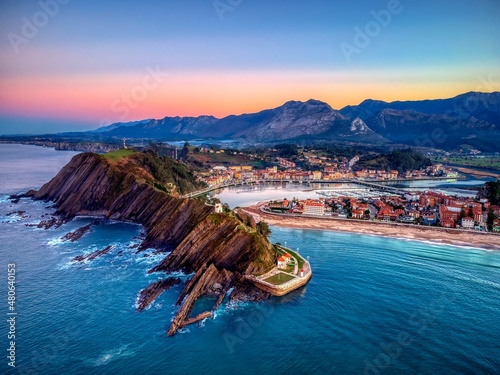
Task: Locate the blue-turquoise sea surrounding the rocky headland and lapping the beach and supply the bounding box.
[0,145,500,374]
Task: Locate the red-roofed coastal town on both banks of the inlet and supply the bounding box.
[202,156,500,232]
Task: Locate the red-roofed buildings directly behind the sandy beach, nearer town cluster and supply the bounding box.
[262,191,500,233]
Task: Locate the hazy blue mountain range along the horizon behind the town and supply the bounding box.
[90,92,500,151]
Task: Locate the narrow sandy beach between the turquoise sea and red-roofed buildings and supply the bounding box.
[243,202,500,250]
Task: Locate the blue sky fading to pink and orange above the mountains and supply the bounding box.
[0,0,500,134]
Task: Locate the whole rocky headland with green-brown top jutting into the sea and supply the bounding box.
[15,149,310,335]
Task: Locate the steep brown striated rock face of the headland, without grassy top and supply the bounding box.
[26,153,275,334]
